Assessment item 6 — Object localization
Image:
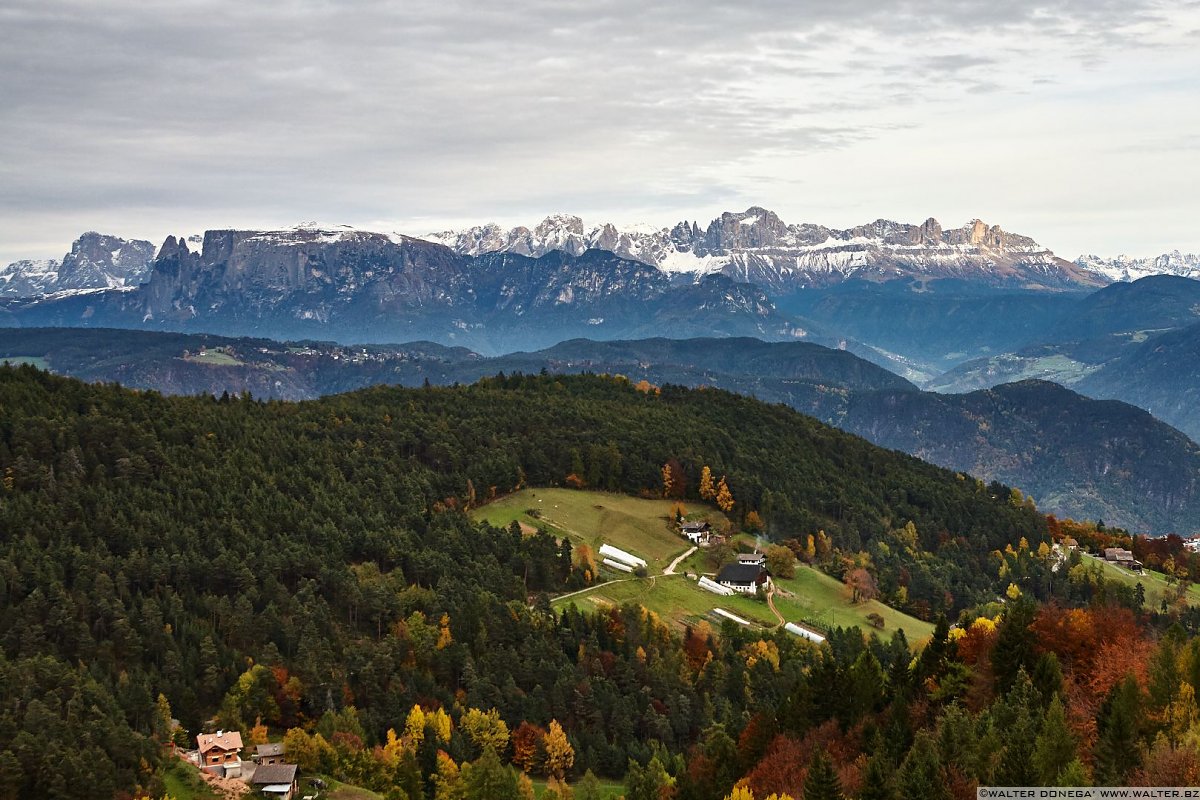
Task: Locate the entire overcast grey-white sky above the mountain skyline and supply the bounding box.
[0,0,1200,264]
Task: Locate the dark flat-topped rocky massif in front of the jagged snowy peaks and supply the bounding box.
[6,225,805,353]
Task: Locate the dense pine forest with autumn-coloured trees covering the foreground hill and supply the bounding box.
[0,367,1200,800]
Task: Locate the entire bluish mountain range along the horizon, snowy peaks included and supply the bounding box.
[7,207,1200,455]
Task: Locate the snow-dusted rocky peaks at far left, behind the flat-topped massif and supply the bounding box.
[0,231,154,297]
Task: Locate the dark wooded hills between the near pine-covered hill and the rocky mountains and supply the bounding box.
[0,329,1200,533]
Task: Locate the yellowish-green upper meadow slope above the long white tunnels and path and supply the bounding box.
[474,489,696,575]
